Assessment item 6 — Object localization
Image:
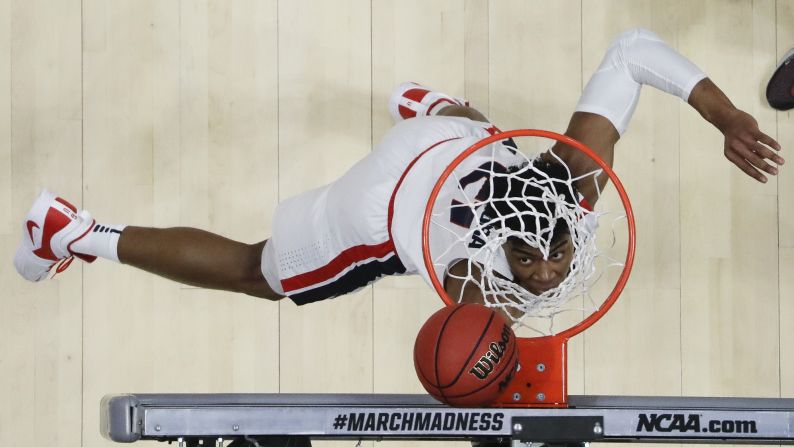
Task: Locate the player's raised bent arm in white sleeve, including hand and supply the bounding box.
[552,28,783,203]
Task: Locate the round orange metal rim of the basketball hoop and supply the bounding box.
[422,129,635,339]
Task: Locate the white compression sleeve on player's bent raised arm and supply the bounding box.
[576,28,706,135]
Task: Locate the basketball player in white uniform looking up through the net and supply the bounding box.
[14,29,784,305]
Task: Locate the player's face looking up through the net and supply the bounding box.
[504,234,573,295]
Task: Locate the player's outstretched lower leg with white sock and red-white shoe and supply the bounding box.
[14,191,280,299]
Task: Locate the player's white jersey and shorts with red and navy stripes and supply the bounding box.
[262,117,524,304]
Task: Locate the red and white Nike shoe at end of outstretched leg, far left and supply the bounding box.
[14,189,96,281]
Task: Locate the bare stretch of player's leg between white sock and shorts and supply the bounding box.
[118,227,283,300]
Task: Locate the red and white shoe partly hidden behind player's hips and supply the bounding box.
[389,82,469,122]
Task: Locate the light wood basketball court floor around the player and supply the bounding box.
[0,0,794,446]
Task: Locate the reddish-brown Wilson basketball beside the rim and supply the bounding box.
[414,304,518,407]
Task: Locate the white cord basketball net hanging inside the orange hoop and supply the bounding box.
[430,143,625,335]
